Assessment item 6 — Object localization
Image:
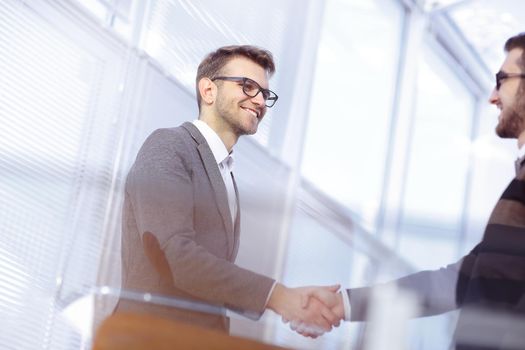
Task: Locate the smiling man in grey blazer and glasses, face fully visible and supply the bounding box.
[117,46,338,337]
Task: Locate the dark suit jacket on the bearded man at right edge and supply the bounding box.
[347,165,525,350]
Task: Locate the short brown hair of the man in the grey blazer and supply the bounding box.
[195,45,275,111]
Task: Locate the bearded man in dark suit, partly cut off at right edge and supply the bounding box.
[304,33,525,350]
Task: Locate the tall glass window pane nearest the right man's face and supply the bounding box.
[400,46,475,268]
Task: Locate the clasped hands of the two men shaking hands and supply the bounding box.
[267,283,344,338]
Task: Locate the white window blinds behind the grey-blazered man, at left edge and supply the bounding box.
[0,0,130,349]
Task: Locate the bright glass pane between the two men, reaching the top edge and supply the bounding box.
[302,0,404,228]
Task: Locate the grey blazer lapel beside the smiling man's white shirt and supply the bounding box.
[182,122,235,239]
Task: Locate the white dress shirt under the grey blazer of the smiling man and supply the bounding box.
[193,120,238,226]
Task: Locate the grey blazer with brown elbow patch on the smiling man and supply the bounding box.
[116,123,274,330]
